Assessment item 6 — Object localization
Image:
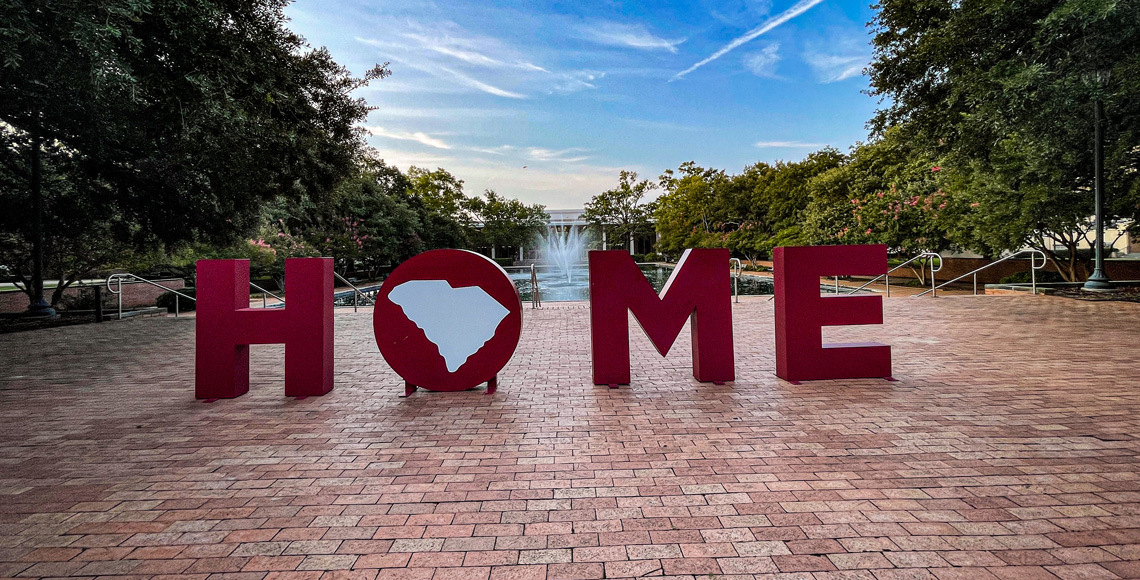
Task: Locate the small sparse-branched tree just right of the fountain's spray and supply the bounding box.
[581,170,657,252]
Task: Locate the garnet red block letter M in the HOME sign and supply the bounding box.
[589,250,735,385]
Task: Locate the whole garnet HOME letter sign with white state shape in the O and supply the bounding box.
[195,245,890,399]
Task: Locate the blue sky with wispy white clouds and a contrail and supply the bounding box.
[286,0,877,209]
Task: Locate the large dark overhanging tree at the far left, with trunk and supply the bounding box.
[0,0,388,312]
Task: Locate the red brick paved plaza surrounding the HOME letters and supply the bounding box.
[0,296,1140,580]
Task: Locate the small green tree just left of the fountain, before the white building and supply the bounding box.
[464,189,549,254]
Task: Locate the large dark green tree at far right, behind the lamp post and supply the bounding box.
[870,0,1140,279]
